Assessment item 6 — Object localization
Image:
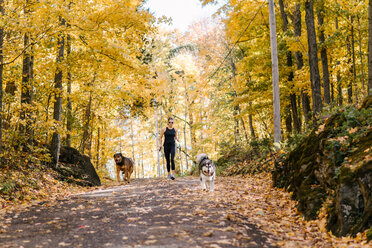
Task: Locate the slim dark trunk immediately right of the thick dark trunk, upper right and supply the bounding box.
[318,0,331,104]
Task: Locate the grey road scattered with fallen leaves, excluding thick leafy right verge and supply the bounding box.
[0,177,272,247]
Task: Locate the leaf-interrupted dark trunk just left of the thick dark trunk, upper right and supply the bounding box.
[294,4,311,123]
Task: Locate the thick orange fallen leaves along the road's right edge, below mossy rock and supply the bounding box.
[214,174,371,247]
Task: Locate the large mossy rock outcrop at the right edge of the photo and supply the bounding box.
[272,98,372,236]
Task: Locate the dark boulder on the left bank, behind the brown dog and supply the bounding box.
[57,146,101,186]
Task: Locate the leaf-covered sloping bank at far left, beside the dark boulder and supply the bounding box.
[0,148,95,209]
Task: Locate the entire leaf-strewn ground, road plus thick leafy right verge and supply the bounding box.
[0,174,371,247]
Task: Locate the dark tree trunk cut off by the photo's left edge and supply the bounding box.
[0,0,4,155]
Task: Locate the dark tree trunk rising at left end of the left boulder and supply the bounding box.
[51,18,65,168]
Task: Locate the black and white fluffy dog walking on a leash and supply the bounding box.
[196,153,216,191]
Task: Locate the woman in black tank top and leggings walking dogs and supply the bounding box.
[159,117,180,180]
